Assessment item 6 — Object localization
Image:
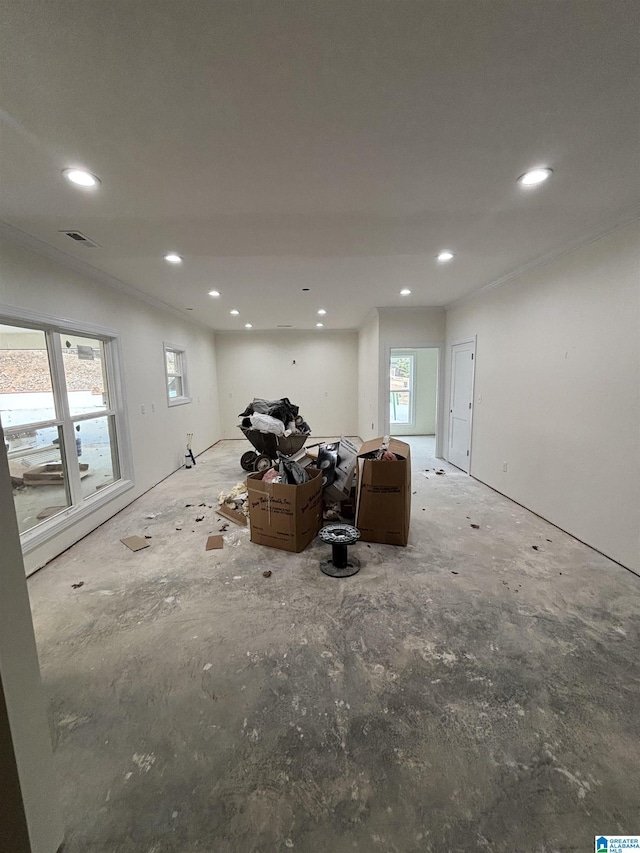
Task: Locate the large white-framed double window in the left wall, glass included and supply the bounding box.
[0,317,127,546]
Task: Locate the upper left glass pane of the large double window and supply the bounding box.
[0,325,56,429]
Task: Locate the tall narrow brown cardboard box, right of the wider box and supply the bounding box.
[356,438,411,545]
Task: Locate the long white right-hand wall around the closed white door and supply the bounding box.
[446,223,640,570]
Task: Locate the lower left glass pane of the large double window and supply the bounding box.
[5,426,71,533]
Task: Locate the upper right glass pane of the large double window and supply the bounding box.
[59,334,109,417]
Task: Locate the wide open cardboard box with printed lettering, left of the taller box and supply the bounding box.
[247,467,322,553]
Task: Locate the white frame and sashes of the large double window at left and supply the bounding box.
[0,305,134,554]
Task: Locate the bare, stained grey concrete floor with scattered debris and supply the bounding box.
[29,439,640,853]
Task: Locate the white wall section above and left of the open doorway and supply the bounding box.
[376,307,445,438]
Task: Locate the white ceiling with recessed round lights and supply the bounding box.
[0,0,640,329]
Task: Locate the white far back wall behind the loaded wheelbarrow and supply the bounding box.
[216,329,358,439]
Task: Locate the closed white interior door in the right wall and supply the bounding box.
[447,341,475,474]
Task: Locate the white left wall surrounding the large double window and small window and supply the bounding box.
[0,239,220,571]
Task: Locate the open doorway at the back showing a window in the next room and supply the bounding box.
[389,347,439,446]
